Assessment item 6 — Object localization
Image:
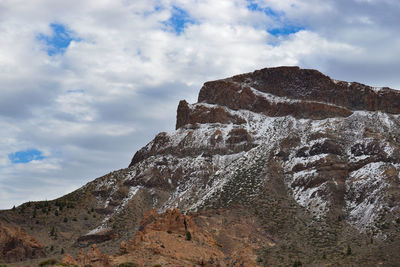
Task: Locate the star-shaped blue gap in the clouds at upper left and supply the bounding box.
[37,23,81,56]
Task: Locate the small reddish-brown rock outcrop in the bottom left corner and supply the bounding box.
[0,223,46,262]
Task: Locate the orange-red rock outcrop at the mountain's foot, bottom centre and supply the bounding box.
[108,209,274,267]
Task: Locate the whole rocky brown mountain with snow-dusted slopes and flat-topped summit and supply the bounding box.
[0,67,400,266]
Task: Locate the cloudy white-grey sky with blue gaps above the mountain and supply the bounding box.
[0,0,400,209]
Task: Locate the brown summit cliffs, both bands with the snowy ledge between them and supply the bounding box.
[176,67,400,129]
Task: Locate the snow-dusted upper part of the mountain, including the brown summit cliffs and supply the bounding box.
[125,67,400,238]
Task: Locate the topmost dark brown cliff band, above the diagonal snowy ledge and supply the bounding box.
[199,67,400,114]
